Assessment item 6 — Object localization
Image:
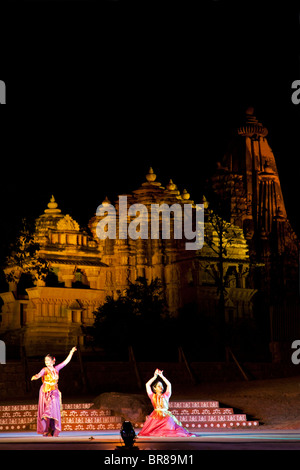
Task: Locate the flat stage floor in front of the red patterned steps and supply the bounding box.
[0,429,300,451]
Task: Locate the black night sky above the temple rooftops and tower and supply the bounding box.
[0,0,300,258]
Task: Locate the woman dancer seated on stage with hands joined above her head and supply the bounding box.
[138,369,195,437]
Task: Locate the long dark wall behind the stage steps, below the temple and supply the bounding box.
[0,360,300,402]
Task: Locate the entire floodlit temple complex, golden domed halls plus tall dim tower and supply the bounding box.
[0,110,298,356]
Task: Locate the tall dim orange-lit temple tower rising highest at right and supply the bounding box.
[212,108,299,303]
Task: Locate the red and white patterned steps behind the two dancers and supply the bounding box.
[0,400,259,432]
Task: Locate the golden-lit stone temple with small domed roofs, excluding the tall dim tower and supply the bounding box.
[0,173,255,356]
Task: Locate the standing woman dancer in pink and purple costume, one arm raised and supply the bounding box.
[31,347,77,436]
